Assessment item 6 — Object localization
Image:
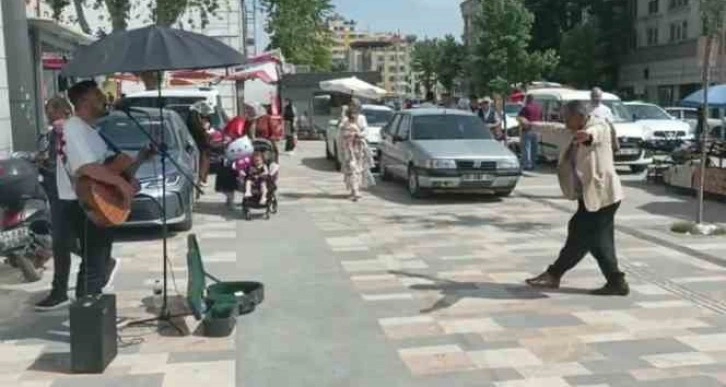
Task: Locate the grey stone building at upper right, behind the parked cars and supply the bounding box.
[619,0,726,105]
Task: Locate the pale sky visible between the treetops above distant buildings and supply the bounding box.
[258,0,464,47]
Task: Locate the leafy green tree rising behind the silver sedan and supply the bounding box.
[470,0,558,95]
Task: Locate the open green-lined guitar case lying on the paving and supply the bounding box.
[187,234,264,337]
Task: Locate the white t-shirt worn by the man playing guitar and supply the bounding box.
[56,117,113,200]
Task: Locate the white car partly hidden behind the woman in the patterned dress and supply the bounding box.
[325,105,393,169]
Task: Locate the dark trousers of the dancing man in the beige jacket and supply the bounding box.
[547,200,623,281]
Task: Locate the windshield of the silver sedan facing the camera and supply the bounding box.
[412,114,492,140]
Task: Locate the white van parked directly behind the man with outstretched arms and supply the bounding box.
[528,88,653,172]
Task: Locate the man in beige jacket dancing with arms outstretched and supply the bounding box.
[526,101,630,296]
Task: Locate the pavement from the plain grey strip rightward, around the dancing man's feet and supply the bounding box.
[237,143,726,387]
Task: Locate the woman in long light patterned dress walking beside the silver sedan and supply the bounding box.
[338,99,375,201]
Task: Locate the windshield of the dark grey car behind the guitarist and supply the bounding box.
[99,116,179,151]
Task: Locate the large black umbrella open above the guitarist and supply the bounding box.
[63,25,245,77]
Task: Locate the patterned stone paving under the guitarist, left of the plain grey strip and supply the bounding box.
[0,194,242,387]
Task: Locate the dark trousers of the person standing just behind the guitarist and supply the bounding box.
[50,197,77,294]
